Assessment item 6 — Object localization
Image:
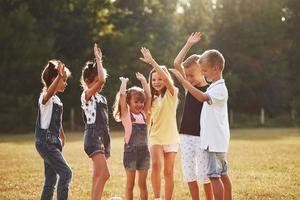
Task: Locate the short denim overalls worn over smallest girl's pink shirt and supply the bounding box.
[123,113,150,170]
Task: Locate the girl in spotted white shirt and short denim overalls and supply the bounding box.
[81,44,110,200]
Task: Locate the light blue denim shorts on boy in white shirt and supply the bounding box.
[207,151,228,178]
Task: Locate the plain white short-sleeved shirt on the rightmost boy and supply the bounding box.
[200,79,230,152]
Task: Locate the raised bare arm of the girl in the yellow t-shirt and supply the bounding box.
[140,47,174,95]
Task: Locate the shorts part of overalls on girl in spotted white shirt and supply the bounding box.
[84,128,105,158]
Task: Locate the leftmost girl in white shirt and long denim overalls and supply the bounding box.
[35,60,72,199]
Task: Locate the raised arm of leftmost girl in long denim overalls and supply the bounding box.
[42,62,66,104]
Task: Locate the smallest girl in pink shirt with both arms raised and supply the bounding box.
[114,73,151,200]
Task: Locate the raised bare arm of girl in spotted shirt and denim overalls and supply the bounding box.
[85,43,105,101]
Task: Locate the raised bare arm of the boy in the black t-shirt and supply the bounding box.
[174,32,201,78]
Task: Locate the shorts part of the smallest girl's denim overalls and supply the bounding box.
[123,144,150,170]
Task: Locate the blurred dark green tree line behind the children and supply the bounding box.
[0,0,300,132]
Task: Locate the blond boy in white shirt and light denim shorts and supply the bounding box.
[172,50,232,200]
